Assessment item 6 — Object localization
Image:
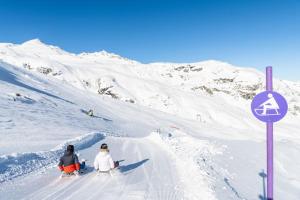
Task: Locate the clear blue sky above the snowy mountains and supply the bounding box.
[0,0,300,80]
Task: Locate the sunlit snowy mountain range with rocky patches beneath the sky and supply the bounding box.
[0,39,300,126]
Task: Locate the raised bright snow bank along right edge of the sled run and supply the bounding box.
[149,129,247,200]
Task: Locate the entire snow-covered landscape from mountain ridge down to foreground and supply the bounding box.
[0,40,300,200]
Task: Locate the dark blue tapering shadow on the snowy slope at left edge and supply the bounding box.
[0,63,74,104]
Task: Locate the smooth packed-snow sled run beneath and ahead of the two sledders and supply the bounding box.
[2,137,183,200]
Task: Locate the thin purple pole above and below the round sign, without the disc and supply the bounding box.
[266,67,273,200]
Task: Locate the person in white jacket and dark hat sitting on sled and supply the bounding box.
[94,143,119,173]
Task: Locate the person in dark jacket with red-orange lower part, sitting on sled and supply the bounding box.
[58,145,85,175]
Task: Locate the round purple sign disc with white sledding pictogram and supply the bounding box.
[251,91,288,122]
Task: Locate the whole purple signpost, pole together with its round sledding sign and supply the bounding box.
[251,67,288,200]
